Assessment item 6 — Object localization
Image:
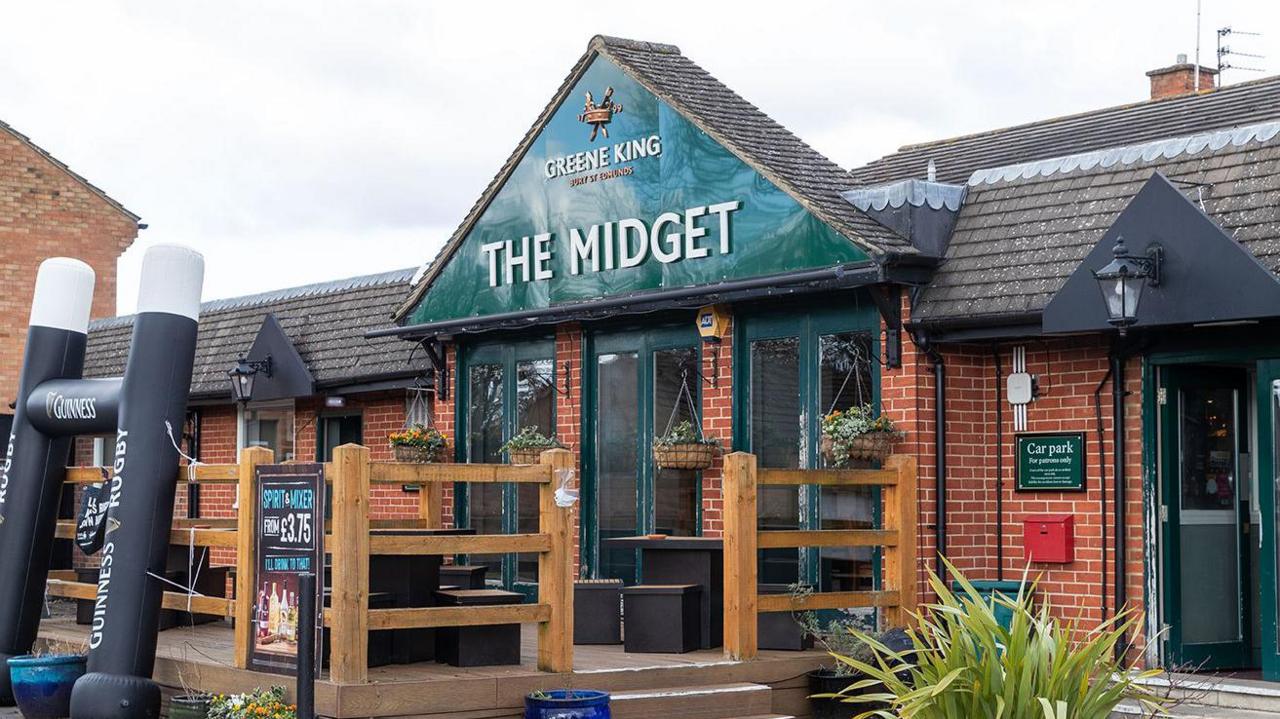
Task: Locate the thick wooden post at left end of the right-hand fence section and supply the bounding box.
[724,452,758,660]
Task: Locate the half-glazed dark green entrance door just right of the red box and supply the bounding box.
[1160,366,1256,669]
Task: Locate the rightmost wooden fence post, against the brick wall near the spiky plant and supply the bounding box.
[881,454,916,627]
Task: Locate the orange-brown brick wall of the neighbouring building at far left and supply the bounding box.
[0,129,138,413]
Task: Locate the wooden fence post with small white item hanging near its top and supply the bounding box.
[538,449,576,672]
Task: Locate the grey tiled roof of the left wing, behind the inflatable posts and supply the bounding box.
[84,269,413,399]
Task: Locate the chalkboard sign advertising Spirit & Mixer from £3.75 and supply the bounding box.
[241,464,325,676]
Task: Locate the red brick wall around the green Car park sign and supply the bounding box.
[882,330,1144,627]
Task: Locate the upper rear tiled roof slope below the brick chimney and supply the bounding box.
[850,77,1280,184]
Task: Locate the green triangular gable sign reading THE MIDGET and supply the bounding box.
[404,56,868,324]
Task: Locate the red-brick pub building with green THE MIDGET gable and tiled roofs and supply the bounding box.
[72,37,1280,679]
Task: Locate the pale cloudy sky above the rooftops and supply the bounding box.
[0,0,1280,312]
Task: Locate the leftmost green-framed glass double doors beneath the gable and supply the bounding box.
[456,340,556,595]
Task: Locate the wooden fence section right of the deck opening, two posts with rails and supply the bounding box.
[723,452,916,659]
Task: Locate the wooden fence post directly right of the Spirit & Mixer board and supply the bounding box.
[326,444,369,684]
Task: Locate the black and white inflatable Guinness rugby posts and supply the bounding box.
[0,244,204,719]
